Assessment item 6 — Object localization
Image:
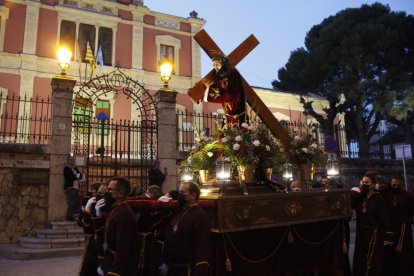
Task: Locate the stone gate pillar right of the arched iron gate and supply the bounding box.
[155,88,178,192]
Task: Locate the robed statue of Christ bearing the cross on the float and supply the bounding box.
[204,55,246,125]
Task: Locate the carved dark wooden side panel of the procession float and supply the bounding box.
[207,190,351,232]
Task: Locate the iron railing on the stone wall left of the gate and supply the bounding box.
[0,92,52,144]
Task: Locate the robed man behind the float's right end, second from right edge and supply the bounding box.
[352,172,393,276]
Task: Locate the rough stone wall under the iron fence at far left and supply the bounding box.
[0,144,49,243]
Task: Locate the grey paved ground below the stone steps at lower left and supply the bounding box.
[0,221,355,276]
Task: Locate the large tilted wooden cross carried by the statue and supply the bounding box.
[188,29,289,140]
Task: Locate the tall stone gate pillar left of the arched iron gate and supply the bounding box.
[48,77,76,222]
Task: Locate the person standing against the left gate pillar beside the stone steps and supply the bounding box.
[63,158,82,221]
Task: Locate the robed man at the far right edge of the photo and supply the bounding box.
[385,175,414,276]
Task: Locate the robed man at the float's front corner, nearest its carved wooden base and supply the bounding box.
[161,182,211,276]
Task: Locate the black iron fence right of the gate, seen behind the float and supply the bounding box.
[177,111,393,159]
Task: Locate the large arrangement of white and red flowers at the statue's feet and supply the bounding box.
[186,121,283,182]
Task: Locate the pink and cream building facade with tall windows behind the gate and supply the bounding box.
[0,0,334,129]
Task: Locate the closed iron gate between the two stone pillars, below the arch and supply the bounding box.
[72,117,157,195]
